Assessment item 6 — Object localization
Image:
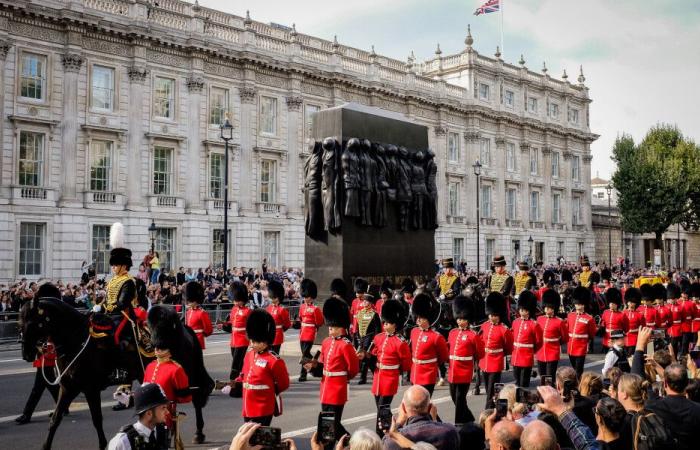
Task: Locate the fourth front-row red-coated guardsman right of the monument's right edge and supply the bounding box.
[536,289,569,379]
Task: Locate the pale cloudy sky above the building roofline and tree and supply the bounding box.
[199,0,700,179]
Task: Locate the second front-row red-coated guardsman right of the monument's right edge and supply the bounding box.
[479,291,513,409]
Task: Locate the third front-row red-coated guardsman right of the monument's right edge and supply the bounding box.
[511,290,542,387]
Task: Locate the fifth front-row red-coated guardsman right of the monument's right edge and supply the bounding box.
[566,286,597,378]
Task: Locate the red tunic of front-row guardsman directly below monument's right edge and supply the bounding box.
[411,327,448,386]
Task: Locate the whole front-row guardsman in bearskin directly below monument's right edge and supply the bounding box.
[411,292,448,395]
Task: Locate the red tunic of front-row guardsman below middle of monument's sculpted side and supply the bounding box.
[370,333,411,397]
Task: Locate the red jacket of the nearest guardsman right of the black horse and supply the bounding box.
[237,349,289,417]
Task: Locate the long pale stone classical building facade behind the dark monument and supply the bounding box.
[0,0,597,280]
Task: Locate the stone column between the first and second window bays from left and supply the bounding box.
[60,52,85,205]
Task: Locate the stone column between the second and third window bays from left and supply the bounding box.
[126,64,148,210]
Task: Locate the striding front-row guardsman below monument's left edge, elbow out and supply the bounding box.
[305,297,360,440]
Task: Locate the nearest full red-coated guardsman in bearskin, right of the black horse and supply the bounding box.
[236,309,289,426]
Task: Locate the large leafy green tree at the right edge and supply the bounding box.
[612,125,700,265]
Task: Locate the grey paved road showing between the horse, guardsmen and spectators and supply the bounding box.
[0,330,603,450]
